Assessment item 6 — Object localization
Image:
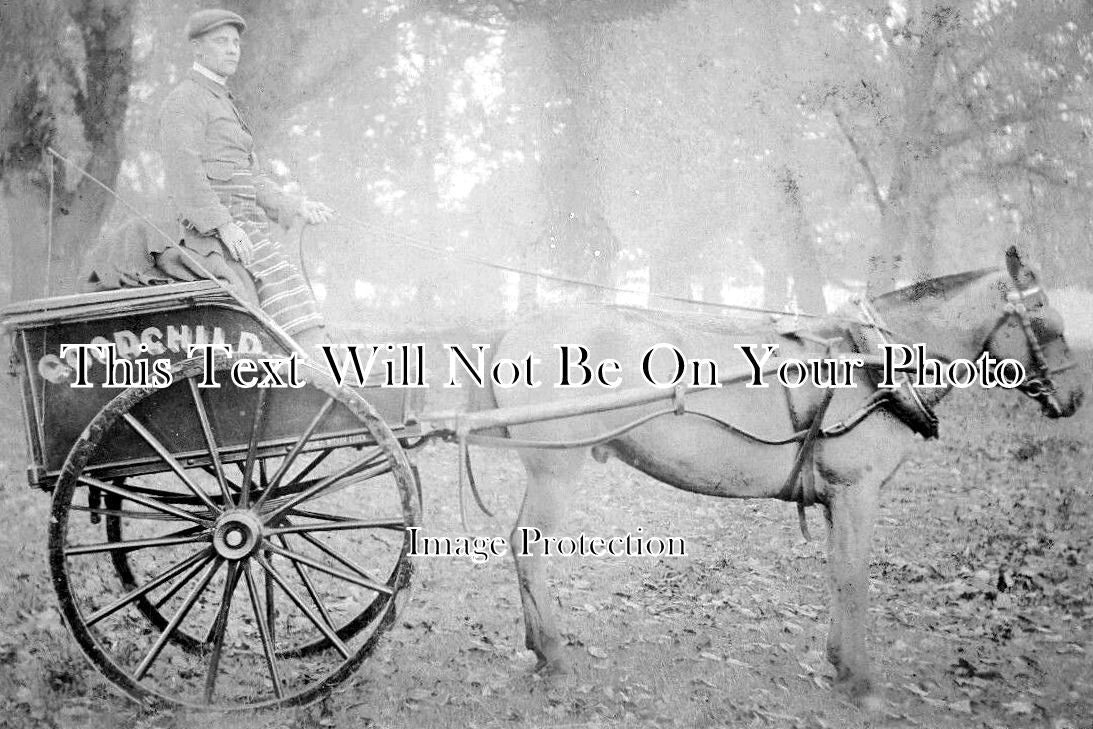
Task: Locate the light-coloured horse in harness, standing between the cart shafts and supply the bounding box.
[474,248,1082,706]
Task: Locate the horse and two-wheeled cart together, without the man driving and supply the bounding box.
[0,249,1081,709]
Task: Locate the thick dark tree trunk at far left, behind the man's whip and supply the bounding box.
[0,0,133,299]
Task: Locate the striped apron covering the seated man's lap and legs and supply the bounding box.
[209,169,322,334]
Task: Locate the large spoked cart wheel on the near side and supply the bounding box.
[49,361,421,709]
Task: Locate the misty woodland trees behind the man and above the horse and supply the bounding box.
[0,0,1093,326]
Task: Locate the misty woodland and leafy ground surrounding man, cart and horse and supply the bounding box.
[0,0,1093,729]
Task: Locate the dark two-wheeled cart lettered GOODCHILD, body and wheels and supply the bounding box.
[3,282,421,708]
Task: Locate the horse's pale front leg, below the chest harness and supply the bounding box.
[824,477,880,709]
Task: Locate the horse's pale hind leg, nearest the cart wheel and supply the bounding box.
[508,452,580,672]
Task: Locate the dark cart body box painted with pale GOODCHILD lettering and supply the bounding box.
[0,282,408,489]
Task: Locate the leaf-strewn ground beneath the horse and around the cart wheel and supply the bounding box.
[0,352,1093,729]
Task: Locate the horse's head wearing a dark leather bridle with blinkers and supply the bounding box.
[984,246,1084,418]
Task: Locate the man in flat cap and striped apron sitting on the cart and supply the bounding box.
[157,9,331,350]
